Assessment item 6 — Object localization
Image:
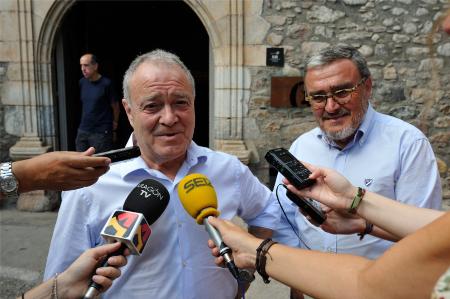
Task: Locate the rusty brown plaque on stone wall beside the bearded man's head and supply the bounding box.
[270,77,307,108]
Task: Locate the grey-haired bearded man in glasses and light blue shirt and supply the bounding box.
[274,45,442,298]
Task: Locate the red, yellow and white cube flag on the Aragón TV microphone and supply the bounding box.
[101,210,151,255]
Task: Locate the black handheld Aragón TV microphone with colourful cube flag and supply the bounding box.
[84,179,170,299]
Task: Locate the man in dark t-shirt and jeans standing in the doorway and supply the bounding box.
[75,53,120,153]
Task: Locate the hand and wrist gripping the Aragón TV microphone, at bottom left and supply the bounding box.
[18,242,129,299]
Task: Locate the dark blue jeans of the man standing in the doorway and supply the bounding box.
[75,130,113,153]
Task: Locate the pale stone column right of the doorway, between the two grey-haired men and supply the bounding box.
[214,0,250,164]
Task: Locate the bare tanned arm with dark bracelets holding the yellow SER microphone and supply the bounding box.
[208,212,450,299]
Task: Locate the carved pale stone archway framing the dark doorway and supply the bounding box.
[19,0,267,162]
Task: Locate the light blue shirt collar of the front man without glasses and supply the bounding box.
[116,141,208,180]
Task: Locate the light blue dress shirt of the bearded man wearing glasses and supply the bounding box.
[274,105,442,258]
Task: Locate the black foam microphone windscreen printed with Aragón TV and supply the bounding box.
[123,179,170,224]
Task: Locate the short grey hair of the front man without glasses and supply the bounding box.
[122,49,195,104]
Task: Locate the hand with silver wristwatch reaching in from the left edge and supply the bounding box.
[0,147,111,203]
